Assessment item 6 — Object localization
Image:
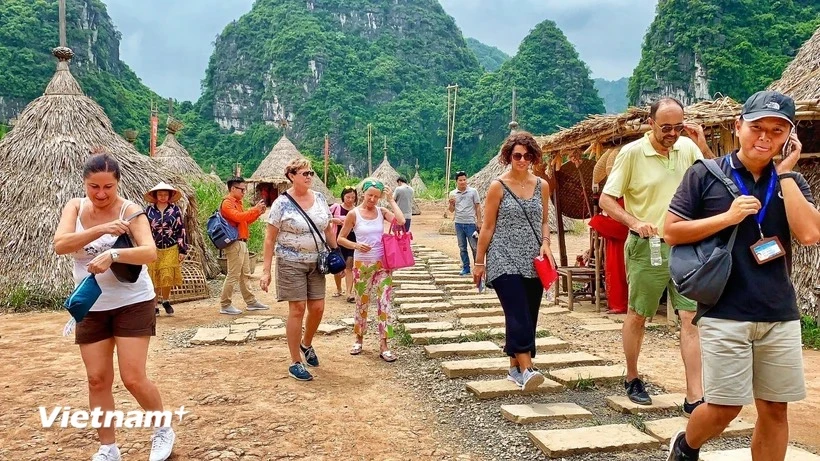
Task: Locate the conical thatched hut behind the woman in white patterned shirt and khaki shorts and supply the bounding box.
[247,135,338,203]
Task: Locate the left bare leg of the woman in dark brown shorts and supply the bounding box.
[80,338,116,445]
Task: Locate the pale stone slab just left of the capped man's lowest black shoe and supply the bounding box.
[527,424,658,459]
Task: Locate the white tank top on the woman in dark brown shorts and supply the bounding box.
[72,197,156,312]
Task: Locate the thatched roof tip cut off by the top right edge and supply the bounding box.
[769,28,820,101]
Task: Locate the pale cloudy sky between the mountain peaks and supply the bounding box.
[105,0,657,101]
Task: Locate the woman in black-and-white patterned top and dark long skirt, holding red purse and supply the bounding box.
[473,131,555,391]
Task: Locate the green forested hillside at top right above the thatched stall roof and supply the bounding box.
[629,0,820,103]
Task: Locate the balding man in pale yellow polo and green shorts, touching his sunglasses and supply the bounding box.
[600,98,713,410]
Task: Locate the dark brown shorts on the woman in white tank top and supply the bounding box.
[74,299,157,344]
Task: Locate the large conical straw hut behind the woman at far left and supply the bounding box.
[0,47,215,305]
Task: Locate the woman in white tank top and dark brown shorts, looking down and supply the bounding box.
[54,153,176,461]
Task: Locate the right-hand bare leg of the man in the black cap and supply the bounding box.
[752,399,789,461]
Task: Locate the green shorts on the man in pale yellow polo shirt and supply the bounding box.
[624,234,698,317]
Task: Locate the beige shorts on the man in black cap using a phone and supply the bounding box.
[698,317,806,406]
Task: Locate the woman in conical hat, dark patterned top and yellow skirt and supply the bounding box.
[143,182,188,315]
